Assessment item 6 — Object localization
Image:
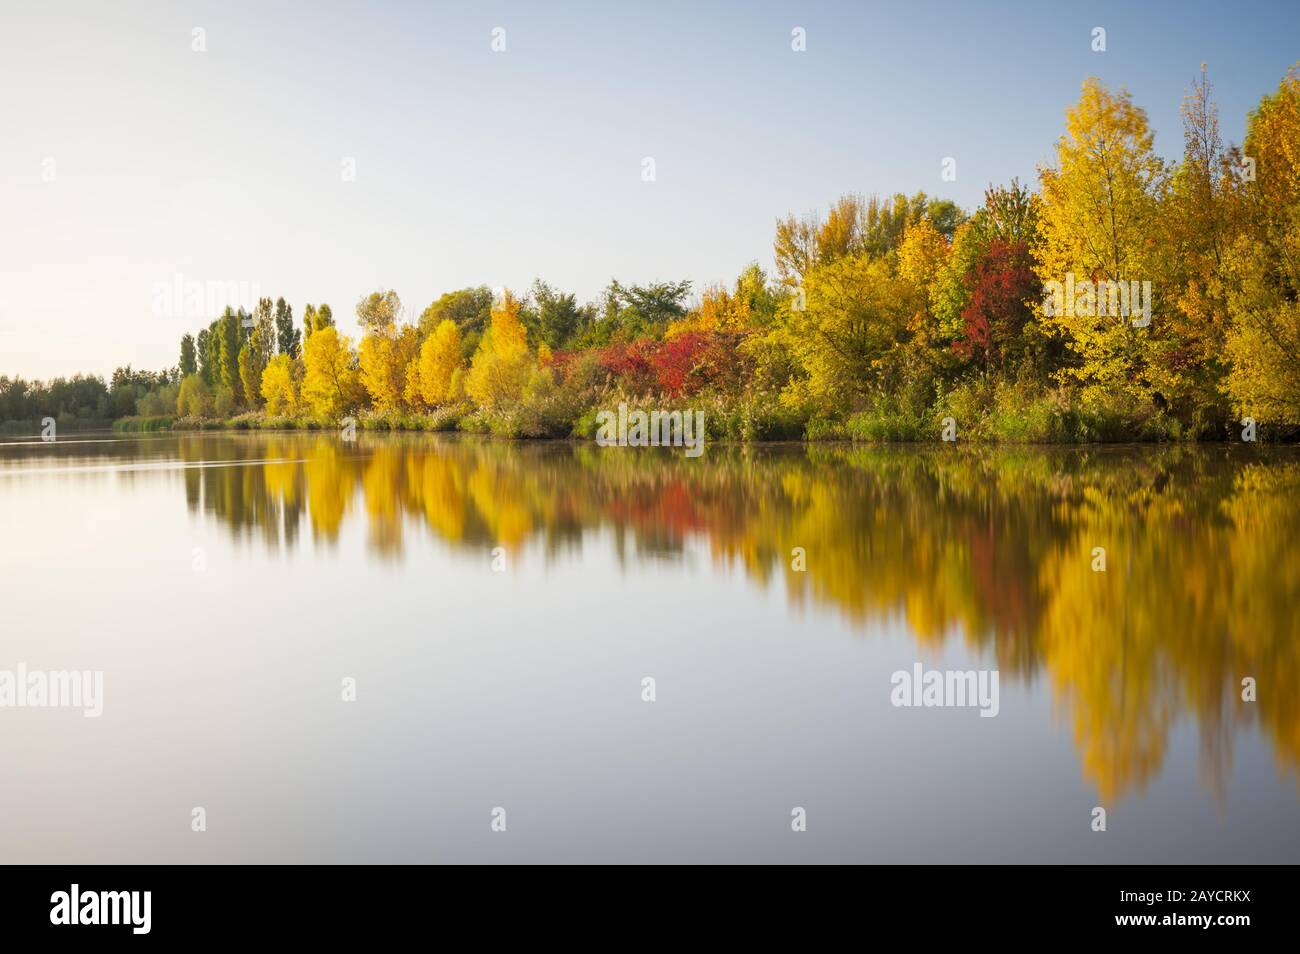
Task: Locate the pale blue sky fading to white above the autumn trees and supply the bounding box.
[0,0,1300,378]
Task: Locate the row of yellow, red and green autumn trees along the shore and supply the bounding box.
[10,66,1300,441]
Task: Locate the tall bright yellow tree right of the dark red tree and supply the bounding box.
[1037,78,1166,403]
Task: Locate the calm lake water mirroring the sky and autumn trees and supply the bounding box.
[0,434,1300,862]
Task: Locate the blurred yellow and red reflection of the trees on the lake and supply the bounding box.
[10,434,1300,802]
